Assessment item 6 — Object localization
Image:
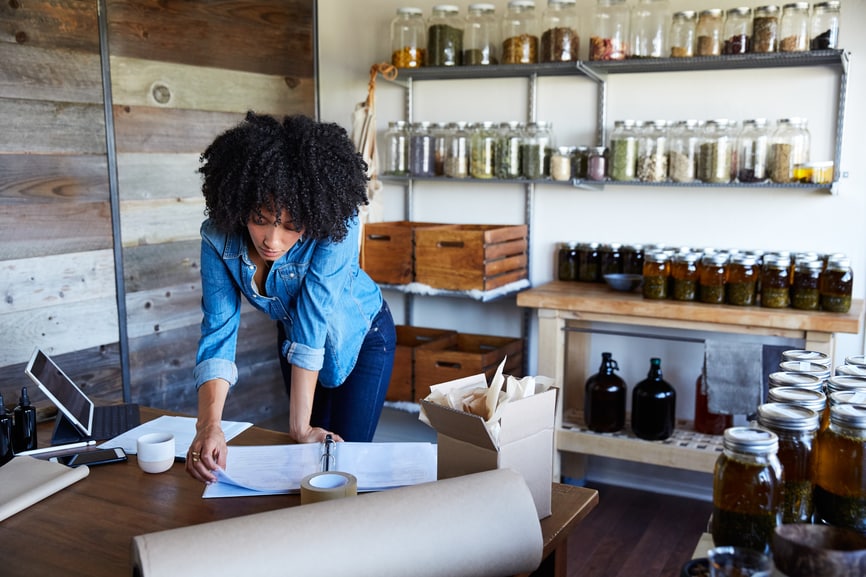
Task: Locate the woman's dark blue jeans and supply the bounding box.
[277,301,397,442]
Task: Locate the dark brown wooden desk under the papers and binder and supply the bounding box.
[0,409,598,577]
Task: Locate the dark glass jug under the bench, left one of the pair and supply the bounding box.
[583,353,626,433]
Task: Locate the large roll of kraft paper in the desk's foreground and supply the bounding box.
[132,469,543,577]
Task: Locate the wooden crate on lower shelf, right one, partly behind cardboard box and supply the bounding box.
[415,333,523,401]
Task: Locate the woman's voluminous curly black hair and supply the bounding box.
[199,111,369,242]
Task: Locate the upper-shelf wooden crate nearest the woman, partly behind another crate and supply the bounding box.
[361,220,442,284]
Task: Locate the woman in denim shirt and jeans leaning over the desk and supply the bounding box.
[186,112,396,483]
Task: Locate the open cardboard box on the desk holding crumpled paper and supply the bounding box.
[421,374,556,519]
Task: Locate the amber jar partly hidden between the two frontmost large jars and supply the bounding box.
[758,403,820,523]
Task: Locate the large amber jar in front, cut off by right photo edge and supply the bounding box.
[813,405,866,533]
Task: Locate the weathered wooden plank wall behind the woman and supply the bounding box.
[0,0,315,422]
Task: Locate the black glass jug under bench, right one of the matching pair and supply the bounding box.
[631,357,677,441]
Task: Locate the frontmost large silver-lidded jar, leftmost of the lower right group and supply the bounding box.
[710,427,783,553]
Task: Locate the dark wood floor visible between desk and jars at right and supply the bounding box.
[568,479,712,577]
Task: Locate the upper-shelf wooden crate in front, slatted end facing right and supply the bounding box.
[415,224,529,291]
